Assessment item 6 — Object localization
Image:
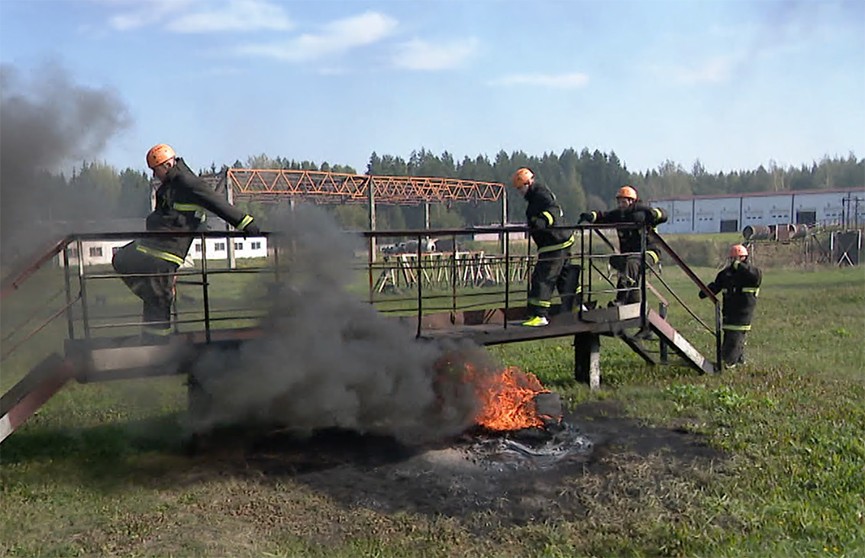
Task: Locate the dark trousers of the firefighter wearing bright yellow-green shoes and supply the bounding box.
[528,248,581,317]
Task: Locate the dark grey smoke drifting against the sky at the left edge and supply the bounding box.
[0,64,129,261]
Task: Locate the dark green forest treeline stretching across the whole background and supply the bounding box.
[37,149,865,229]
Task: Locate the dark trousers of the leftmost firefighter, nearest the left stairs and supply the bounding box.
[111,242,177,337]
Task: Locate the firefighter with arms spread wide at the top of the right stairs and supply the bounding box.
[580,185,667,306]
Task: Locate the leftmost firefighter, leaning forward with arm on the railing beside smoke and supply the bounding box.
[112,144,261,342]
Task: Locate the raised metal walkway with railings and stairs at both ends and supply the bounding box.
[0,219,721,442]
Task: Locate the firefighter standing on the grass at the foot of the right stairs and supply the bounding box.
[700,244,763,366]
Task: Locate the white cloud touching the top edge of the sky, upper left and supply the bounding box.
[104,0,293,33]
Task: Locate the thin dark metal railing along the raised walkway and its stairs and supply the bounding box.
[0,225,721,372]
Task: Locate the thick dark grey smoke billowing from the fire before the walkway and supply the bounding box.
[192,206,496,443]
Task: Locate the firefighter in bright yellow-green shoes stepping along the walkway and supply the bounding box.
[513,167,580,327]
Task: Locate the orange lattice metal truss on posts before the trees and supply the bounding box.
[225,169,504,205]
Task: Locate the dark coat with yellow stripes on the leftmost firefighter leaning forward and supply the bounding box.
[139,157,252,265]
